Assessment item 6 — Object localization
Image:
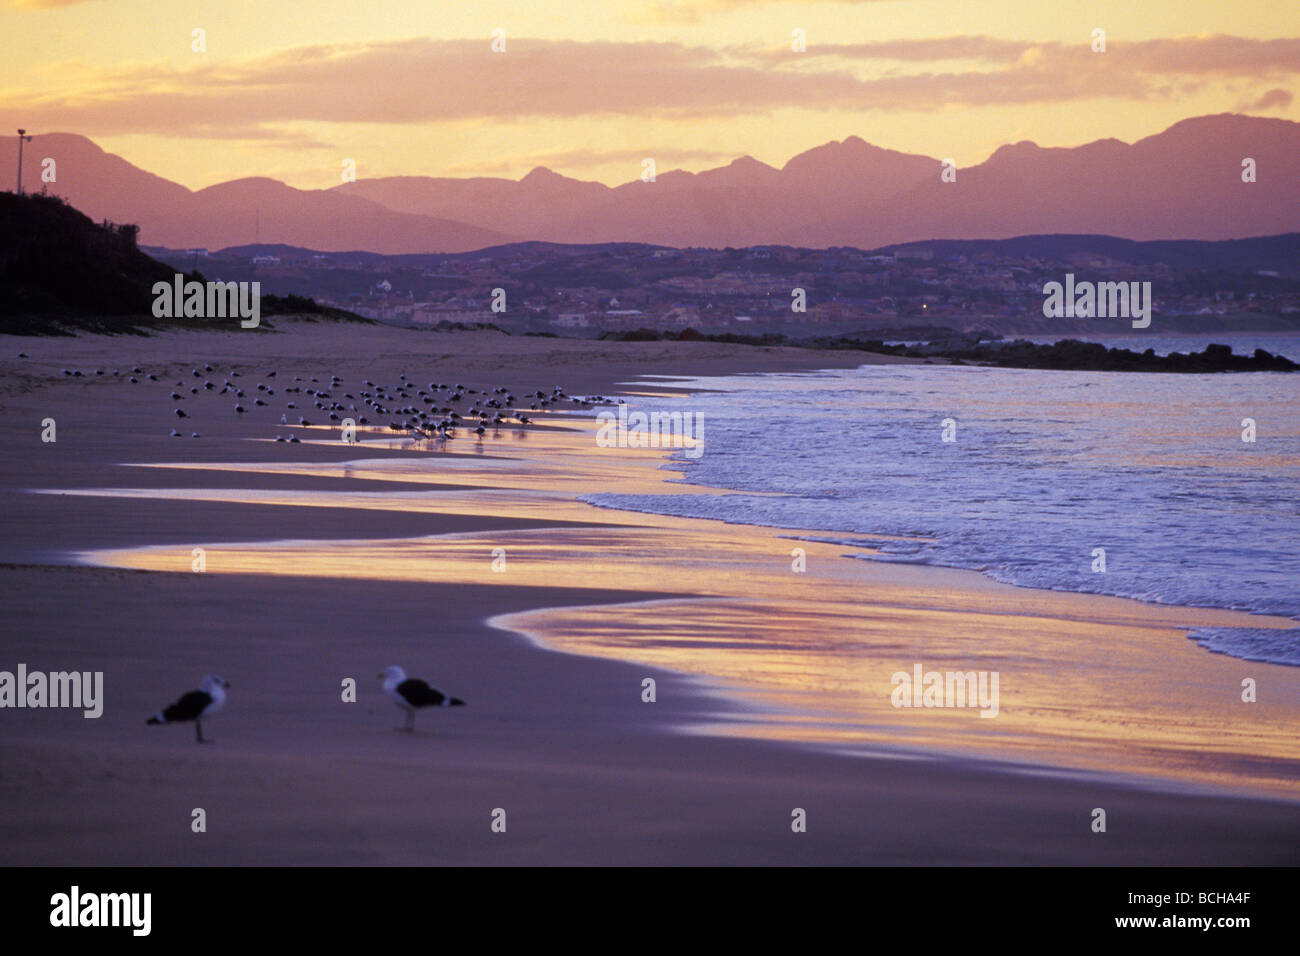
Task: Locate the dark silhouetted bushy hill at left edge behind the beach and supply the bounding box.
[0,193,365,336]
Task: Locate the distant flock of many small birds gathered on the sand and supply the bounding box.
[53,363,614,444]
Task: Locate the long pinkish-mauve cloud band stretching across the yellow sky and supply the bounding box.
[0,35,1300,139]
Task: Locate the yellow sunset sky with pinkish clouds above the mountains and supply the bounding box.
[0,0,1300,189]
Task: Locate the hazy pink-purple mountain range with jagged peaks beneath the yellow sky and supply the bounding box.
[0,113,1300,254]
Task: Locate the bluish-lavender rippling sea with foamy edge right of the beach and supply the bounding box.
[584,333,1300,666]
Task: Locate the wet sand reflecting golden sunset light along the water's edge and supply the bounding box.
[68,423,1300,797]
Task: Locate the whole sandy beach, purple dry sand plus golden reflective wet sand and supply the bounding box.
[0,323,1300,865]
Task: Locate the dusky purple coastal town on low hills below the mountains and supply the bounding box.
[148,237,1300,338]
